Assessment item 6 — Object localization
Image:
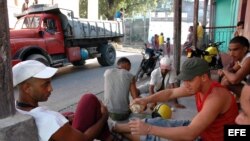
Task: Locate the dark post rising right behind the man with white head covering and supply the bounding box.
[174,0,182,85]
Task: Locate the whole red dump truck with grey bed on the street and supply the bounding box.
[10,5,124,66]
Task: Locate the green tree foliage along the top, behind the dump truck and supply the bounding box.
[80,0,166,19]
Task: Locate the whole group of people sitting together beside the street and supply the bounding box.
[12,36,250,141]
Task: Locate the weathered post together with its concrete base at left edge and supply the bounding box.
[0,0,38,141]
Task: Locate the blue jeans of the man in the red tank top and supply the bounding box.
[140,117,190,141]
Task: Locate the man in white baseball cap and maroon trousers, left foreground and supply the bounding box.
[12,60,112,141]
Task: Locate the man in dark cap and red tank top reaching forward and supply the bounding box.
[112,58,238,141]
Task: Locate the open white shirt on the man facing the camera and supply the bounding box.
[149,68,177,92]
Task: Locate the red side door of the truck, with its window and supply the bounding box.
[42,16,65,54]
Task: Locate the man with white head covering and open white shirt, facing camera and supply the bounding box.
[138,56,185,109]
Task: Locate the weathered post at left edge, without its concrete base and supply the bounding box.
[0,0,16,119]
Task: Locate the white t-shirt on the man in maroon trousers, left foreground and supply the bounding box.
[17,107,68,141]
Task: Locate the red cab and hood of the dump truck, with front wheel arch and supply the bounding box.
[10,13,65,65]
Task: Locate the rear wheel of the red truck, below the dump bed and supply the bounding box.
[97,44,116,66]
